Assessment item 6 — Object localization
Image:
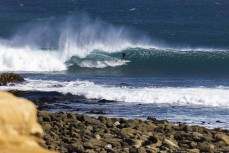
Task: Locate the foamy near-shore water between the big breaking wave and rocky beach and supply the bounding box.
[0,73,229,129]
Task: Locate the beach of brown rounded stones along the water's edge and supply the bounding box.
[38,111,229,153]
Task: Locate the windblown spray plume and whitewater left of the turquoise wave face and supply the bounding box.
[0,15,154,71]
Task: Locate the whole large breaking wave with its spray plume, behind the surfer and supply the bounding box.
[0,15,229,75]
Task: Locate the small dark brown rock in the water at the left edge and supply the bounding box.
[0,73,24,86]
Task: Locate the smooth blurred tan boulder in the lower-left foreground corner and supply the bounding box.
[0,91,55,153]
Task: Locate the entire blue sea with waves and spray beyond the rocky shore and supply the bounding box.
[0,0,229,129]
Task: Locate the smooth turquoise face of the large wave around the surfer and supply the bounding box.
[66,48,229,76]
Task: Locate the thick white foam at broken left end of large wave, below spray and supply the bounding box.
[0,45,66,71]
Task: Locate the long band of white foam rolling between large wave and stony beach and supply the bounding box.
[0,80,229,107]
